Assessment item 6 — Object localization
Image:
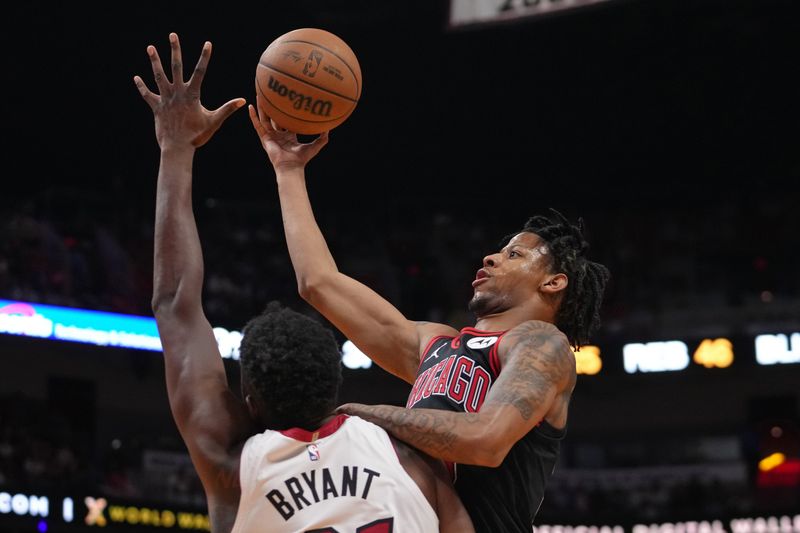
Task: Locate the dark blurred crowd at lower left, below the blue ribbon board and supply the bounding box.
[0,393,206,509]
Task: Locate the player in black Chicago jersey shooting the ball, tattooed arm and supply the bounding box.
[249,106,609,533]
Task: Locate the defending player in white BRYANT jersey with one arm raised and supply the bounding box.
[134,33,474,533]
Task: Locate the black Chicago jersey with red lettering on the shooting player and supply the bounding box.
[406,328,565,533]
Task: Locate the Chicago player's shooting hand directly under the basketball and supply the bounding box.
[248,105,328,170]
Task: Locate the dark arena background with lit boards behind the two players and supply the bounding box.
[0,0,800,533]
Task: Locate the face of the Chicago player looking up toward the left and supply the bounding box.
[469,233,550,316]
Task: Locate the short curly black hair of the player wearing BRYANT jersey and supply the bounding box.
[239,301,342,430]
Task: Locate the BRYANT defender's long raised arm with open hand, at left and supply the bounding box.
[134,33,249,520]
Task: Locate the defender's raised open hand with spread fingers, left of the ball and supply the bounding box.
[133,33,245,151]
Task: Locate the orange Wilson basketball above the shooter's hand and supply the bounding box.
[256,28,361,135]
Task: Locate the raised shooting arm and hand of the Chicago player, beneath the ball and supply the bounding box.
[250,106,454,383]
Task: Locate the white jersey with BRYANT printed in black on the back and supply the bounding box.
[233,415,439,533]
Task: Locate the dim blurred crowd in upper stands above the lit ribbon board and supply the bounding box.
[0,188,800,336]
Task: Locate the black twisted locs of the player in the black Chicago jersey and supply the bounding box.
[506,208,611,349]
